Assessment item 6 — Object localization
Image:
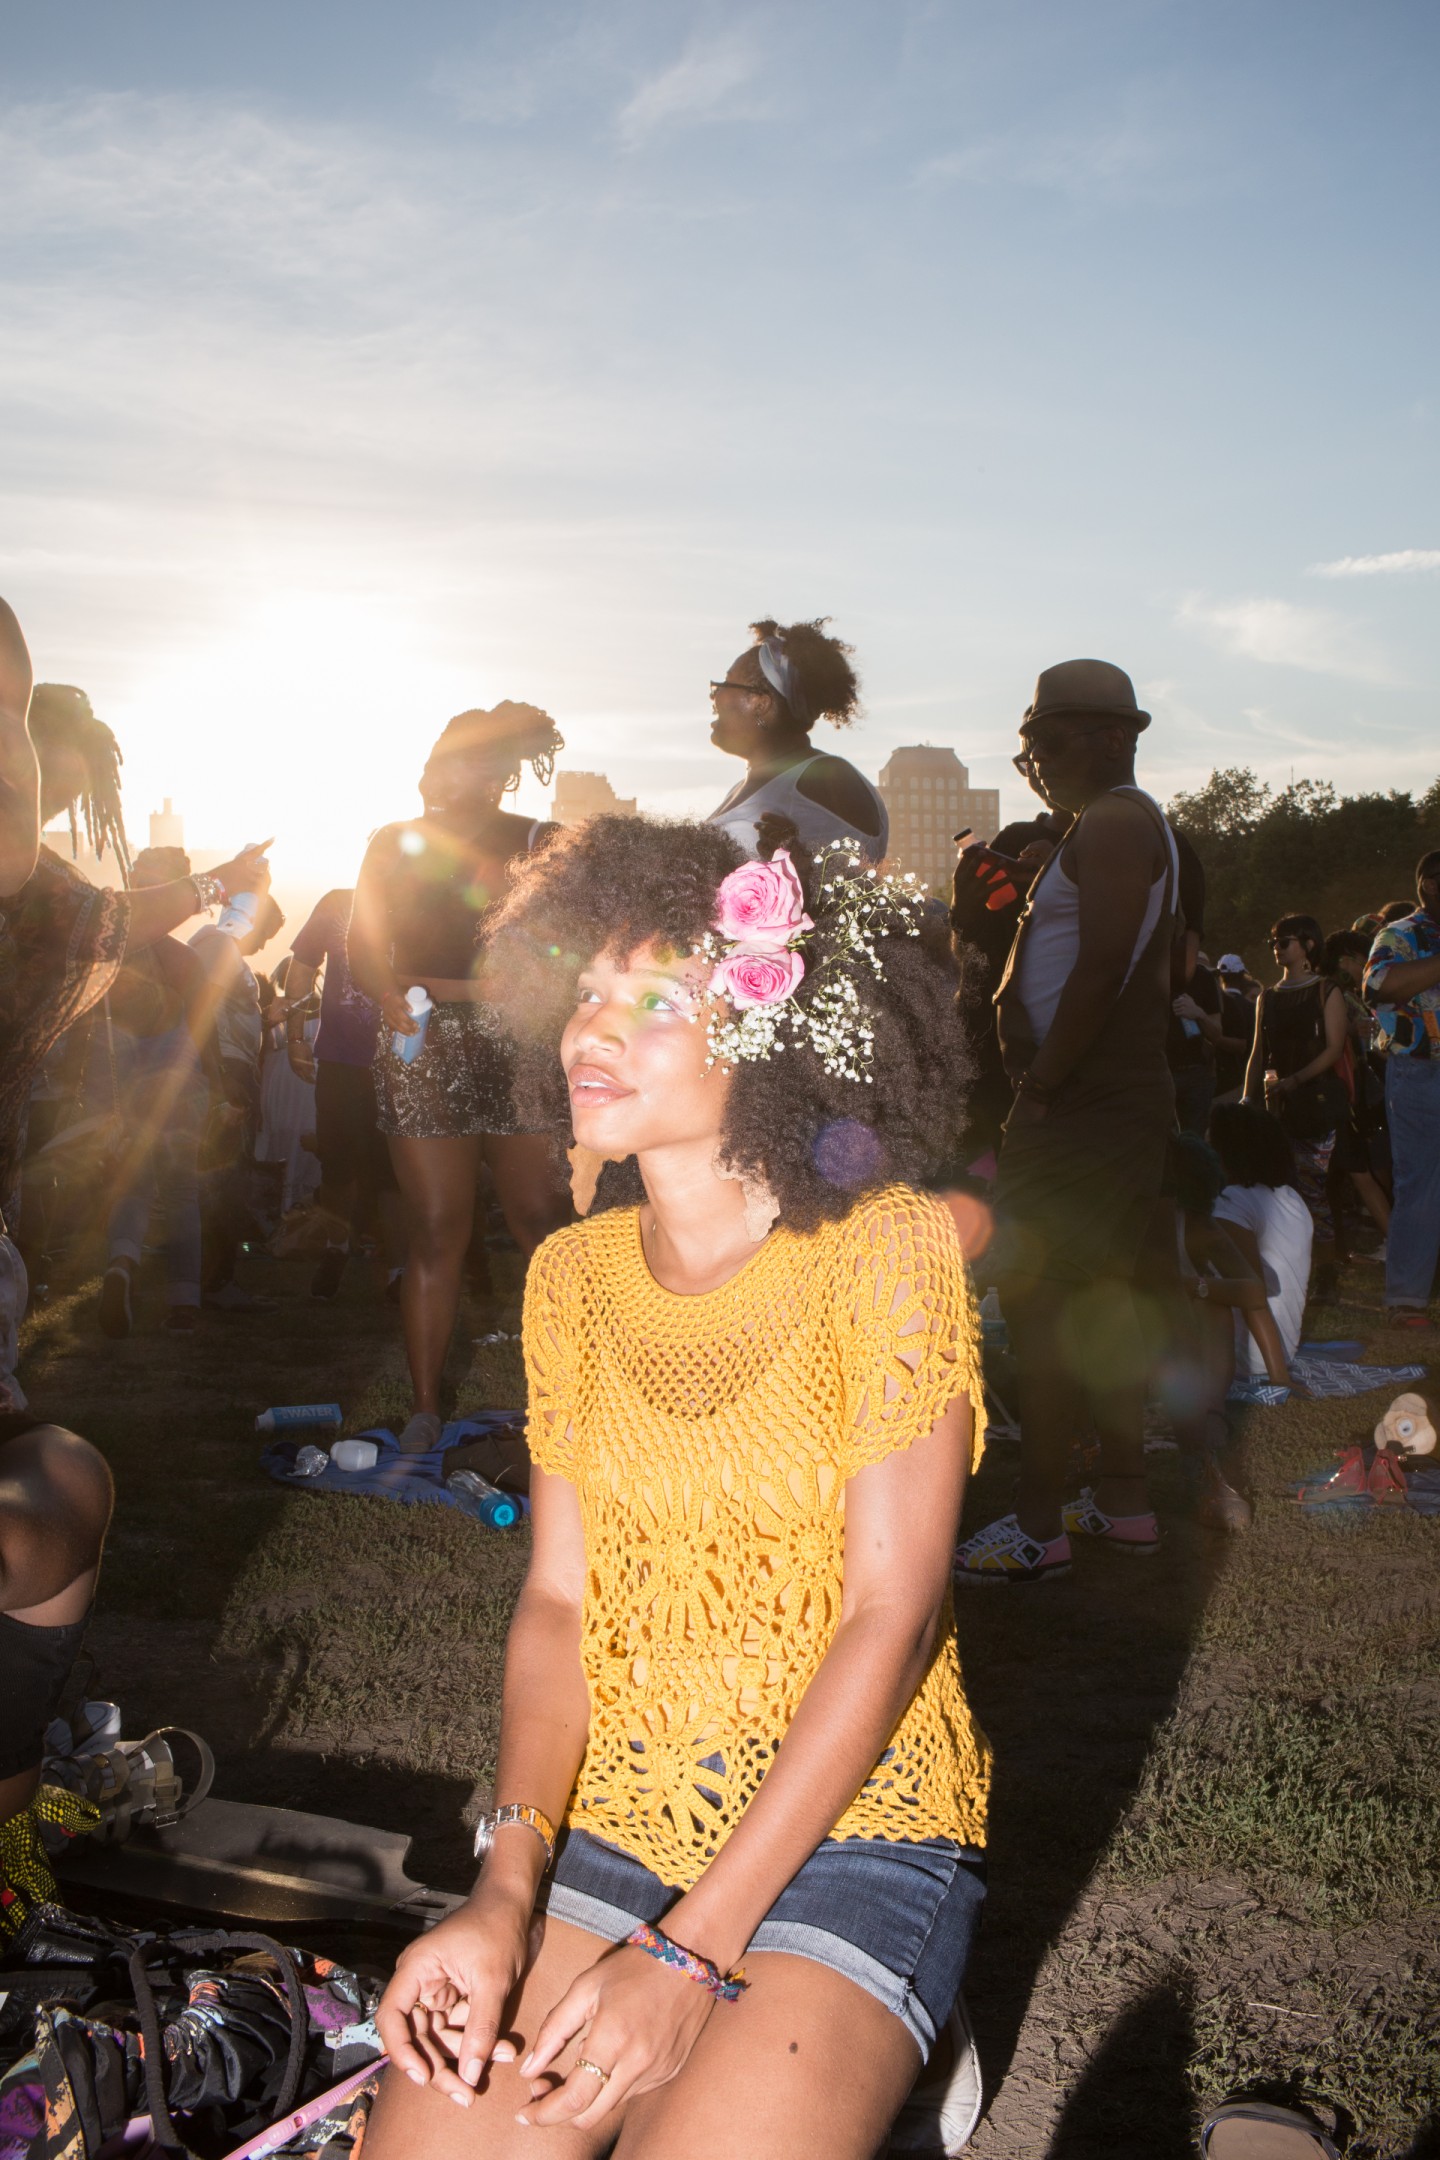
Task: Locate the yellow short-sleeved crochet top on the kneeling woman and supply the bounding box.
[525,1186,989,1890]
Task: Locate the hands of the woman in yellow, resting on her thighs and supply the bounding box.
[376,1879,715,2130]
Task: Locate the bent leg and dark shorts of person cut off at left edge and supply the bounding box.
[0,1413,114,1944]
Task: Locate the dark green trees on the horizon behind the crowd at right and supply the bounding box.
[1168,765,1440,959]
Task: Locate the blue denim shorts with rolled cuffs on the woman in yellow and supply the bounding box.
[540,1830,984,2063]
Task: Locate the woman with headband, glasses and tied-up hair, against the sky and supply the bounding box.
[710,616,889,862]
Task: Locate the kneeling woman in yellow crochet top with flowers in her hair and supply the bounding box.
[365,819,989,2160]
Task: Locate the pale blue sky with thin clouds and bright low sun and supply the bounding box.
[0,0,1440,920]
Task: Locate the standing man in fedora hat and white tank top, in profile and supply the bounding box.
[956,661,1179,1583]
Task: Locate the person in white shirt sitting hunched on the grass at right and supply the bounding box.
[1209,1102,1313,1378]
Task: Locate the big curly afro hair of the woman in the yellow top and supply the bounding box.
[486,816,969,1231]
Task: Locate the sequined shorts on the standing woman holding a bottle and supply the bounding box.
[373,1000,522,1140]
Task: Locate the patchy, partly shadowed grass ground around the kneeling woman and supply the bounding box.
[22,1257,1440,2160]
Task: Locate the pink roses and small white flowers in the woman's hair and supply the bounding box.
[695,840,924,1084]
